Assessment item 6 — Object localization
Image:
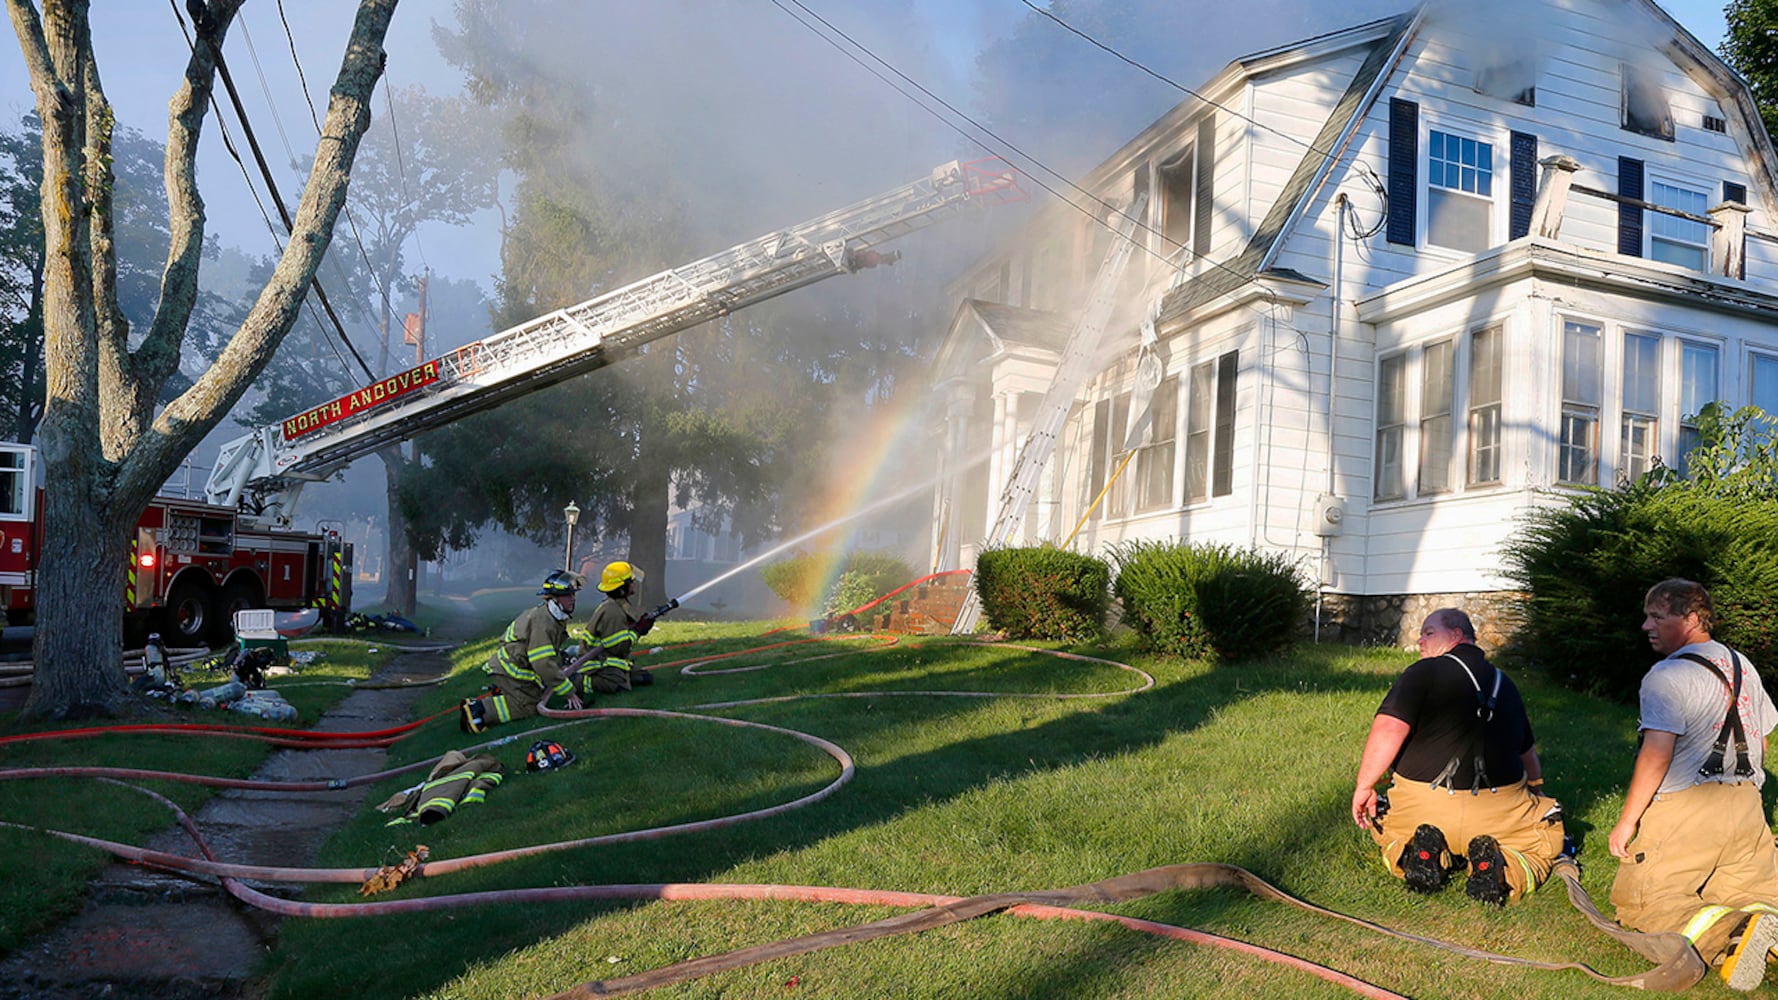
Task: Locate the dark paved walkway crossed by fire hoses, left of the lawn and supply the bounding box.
[0,637,465,1000]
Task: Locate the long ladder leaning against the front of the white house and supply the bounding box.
[951,194,1149,635]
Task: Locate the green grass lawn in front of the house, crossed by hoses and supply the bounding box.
[0,615,1778,1000]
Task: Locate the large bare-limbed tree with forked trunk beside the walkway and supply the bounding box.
[7,0,396,717]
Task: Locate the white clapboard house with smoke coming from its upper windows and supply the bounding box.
[933,0,1778,642]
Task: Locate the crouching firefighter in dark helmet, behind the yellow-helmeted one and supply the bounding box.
[461,569,585,733]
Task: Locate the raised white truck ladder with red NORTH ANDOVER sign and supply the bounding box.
[204,158,1028,525]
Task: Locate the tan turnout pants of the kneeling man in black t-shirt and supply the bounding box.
[1371,765,1563,900]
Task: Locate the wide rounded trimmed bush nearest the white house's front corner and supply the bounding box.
[1111,541,1309,660]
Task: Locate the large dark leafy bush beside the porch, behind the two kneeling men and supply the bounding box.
[1506,479,1778,699]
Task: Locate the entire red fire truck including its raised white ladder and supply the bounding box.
[0,158,1029,644]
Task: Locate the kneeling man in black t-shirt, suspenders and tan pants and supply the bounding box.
[1351,609,1563,904]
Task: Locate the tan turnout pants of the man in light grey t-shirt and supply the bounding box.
[1611,781,1778,963]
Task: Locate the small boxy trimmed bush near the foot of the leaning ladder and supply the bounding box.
[974,548,1111,642]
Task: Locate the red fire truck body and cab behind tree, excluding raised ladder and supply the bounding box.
[0,441,352,644]
